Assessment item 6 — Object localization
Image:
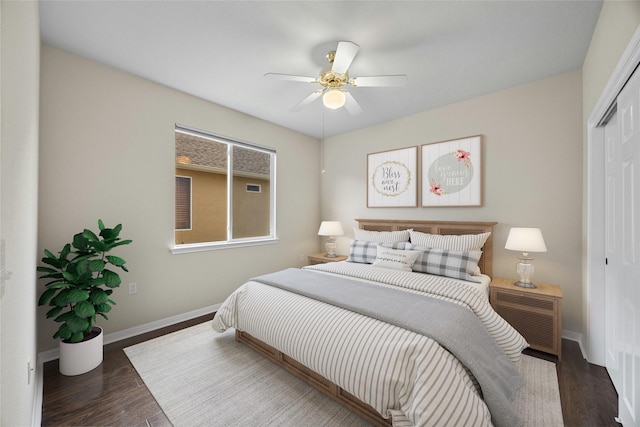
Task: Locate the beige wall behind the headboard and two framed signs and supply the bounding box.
[321,71,582,333]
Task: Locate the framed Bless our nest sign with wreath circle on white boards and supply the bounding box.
[367,147,418,208]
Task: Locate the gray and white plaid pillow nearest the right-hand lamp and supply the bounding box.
[407,244,482,282]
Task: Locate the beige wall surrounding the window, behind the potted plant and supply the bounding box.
[38,45,320,351]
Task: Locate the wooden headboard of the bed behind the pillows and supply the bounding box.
[356,219,497,277]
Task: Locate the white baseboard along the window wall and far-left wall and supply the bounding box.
[31,303,222,427]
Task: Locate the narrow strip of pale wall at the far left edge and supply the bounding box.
[0,1,40,426]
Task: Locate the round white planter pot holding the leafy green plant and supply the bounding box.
[59,326,104,376]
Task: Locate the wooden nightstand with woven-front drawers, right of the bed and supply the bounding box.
[490,278,562,361]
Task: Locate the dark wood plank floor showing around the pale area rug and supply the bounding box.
[42,316,619,427]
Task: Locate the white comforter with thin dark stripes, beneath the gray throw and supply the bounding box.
[213,262,527,426]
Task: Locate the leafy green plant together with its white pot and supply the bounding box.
[37,220,131,375]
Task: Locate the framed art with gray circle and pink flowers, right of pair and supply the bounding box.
[421,135,482,207]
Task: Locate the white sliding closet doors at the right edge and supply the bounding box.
[606,64,640,426]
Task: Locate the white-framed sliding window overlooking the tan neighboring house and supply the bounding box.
[172,126,276,253]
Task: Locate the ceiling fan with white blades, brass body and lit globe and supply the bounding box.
[264,41,407,114]
